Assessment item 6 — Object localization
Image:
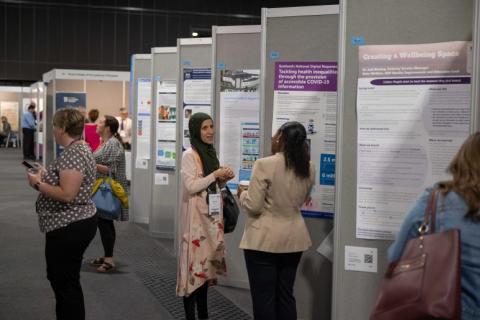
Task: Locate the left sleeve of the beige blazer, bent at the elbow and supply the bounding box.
[239,160,268,216]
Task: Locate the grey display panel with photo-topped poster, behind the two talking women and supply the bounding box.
[212,25,261,288]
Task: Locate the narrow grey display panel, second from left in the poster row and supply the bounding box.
[148,47,180,239]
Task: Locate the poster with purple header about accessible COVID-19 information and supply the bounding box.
[272,61,337,218]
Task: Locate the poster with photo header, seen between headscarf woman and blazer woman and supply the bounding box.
[219,69,260,191]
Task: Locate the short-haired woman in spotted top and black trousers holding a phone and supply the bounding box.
[27,108,97,320]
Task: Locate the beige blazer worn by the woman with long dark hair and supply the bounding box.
[240,152,315,253]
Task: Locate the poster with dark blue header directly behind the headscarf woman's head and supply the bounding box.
[183,68,212,150]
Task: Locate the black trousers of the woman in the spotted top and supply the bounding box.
[45,215,97,320]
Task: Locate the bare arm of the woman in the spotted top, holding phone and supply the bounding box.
[28,169,83,202]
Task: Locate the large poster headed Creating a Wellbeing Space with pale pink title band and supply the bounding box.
[356,41,470,239]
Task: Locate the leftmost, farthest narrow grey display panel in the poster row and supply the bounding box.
[129,54,152,224]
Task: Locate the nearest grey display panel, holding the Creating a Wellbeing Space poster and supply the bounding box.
[332,0,478,320]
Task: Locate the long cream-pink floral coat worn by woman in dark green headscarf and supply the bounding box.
[177,149,226,296]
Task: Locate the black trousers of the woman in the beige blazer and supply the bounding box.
[244,250,302,320]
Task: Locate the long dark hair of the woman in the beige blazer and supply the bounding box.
[278,121,310,178]
